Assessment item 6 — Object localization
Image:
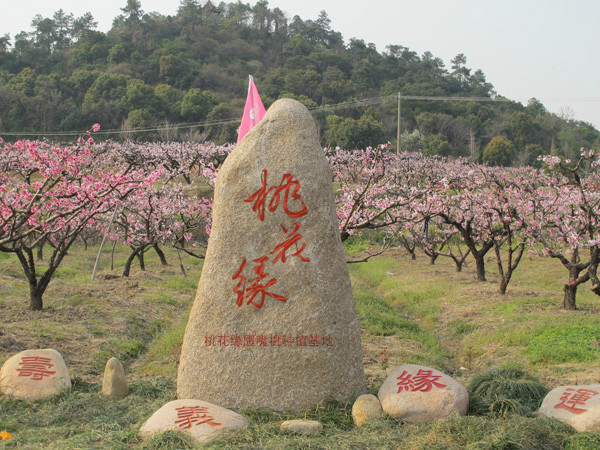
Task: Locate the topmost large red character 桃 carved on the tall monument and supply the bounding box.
[244,169,308,220]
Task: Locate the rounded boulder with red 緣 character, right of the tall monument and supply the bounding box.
[378,364,469,423]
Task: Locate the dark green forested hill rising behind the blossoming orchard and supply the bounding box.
[0,0,600,164]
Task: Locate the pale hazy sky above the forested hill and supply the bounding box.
[0,0,600,130]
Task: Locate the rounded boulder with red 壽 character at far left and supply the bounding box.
[0,349,71,400]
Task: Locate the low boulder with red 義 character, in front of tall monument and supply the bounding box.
[139,399,250,444]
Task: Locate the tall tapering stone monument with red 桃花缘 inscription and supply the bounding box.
[177,99,365,410]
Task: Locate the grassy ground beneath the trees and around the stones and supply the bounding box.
[0,241,600,450]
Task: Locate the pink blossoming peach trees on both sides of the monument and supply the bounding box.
[0,126,600,309]
